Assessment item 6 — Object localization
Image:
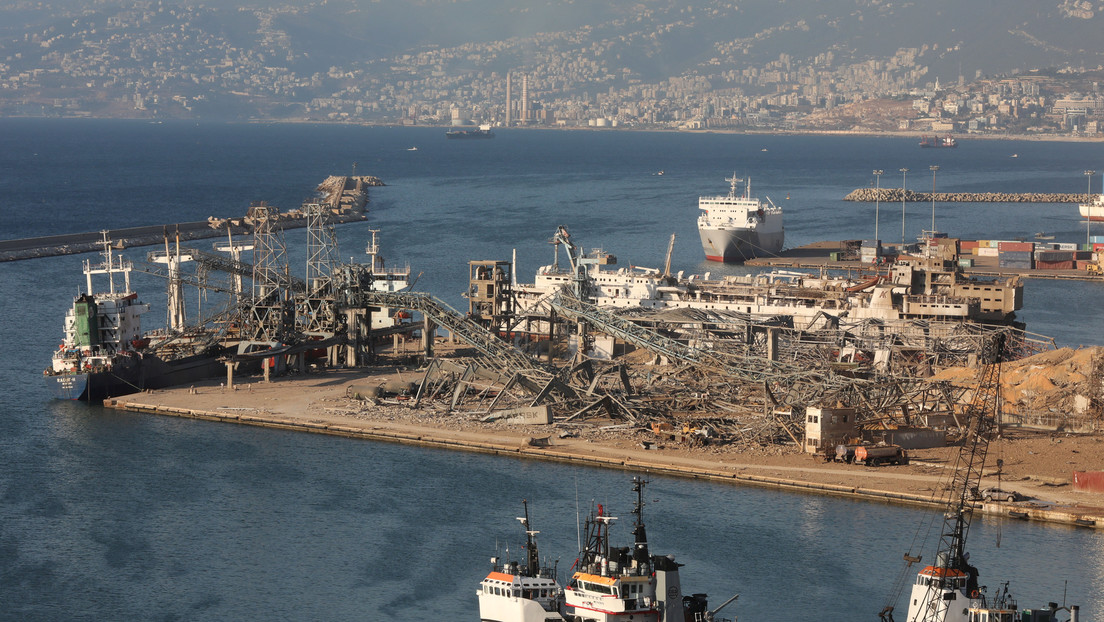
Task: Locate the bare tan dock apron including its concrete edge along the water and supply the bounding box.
[105,368,1104,528]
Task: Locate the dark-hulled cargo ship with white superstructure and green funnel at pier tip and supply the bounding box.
[43,235,227,401]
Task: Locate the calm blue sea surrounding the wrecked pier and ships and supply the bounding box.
[0,119,1104,621]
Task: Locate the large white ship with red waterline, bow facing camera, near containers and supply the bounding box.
[698,175,786,263]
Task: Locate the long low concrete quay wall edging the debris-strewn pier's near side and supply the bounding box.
[104,398,1104,528]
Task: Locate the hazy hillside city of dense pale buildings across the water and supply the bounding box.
[0,3,1104,137]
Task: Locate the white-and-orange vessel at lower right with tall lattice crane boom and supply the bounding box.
[879,337,1080,622]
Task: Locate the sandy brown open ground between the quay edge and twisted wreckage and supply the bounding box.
[126,368,1104,517]
